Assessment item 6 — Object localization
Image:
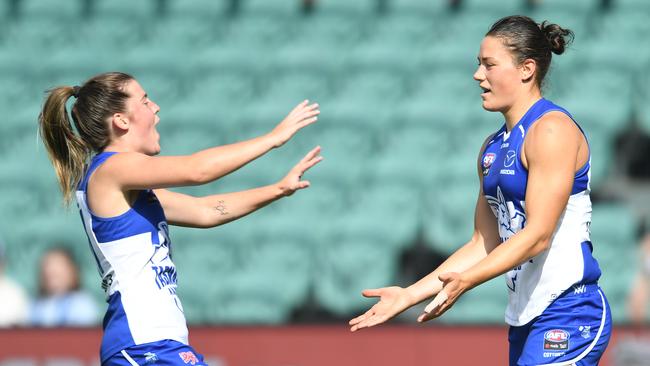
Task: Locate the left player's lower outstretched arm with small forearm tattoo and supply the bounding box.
[155,147,322,228]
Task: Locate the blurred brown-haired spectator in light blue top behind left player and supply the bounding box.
[30,248,99,327]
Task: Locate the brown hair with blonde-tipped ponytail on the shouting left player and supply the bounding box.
[38,72,134,204]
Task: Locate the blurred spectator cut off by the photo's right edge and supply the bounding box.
[628,231,650,325]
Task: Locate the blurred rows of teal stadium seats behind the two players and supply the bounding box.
[0,0,650,364]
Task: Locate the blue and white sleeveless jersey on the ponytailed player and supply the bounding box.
[76,152,187,362]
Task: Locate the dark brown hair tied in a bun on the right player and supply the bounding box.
[485,15,574,87]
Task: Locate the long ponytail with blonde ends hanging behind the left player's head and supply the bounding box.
[38,86,90,205]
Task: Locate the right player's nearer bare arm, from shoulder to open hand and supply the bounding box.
[419,113,584,321]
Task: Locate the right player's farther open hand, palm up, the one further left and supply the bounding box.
[349,286,414,332]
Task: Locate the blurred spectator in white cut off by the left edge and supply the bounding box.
[0,241,29,328]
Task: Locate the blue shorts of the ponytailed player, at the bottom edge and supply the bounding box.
[102,340,207,366]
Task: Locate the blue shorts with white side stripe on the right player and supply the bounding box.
[508,284,612,366]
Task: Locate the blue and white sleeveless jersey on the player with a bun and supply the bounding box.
[481,99,600,326]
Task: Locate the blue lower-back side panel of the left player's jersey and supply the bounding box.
[100,291,135,362]
